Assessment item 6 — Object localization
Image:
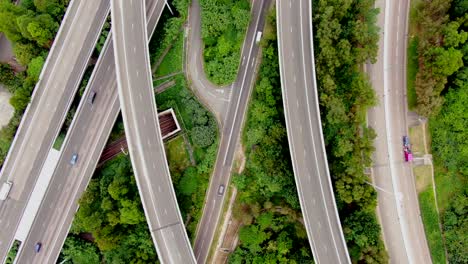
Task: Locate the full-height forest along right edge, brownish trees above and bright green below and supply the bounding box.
[412,0,468,263]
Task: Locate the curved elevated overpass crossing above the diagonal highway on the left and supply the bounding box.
[111,0,195,263]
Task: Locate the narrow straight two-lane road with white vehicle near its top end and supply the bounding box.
[191,0,271,263]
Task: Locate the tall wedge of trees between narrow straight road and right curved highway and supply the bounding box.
[229,10,312,263]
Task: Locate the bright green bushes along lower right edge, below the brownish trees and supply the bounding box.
[430,71,468,263]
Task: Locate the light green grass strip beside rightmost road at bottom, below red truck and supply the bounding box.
[419,185,446,264]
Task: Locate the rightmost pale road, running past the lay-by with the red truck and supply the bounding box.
[367,0,432,263]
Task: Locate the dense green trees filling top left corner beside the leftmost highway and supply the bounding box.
[0,0,69,164]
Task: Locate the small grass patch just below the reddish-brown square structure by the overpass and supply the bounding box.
[166,135,190,174]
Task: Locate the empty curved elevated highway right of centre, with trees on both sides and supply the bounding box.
[276,0,351,263]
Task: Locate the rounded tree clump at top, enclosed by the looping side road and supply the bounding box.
[200,0,250,85]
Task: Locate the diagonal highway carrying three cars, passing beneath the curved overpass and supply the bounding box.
[11,0,164,263]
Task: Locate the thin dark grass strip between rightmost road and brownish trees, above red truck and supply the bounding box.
[406,36,419,110]
